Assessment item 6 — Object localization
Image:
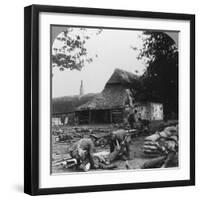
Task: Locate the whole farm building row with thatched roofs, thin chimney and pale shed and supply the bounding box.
[52,69,163,124]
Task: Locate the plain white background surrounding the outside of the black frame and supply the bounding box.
[0,0,200,200]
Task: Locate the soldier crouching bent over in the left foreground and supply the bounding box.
[69,138,95,171]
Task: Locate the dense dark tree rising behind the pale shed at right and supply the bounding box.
[137,31,178,118]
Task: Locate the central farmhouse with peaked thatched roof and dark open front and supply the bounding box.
[75,69,146,124]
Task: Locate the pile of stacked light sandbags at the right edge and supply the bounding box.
[143,126,178,156]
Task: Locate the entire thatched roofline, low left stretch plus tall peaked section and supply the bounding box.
[52,69,140,112]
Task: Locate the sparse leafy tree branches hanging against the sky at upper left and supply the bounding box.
[52,27,102,71]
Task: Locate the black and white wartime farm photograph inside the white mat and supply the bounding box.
[50,24,180,175]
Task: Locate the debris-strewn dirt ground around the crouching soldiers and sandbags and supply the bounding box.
[51,121,177,173]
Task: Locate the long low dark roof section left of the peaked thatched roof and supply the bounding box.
[52,93,97,115]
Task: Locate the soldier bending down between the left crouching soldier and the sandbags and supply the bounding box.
[109,130,130,160]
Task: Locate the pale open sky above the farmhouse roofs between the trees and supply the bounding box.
[52,29,144,97]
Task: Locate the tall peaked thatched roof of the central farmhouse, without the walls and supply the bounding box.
[77,69,140,111]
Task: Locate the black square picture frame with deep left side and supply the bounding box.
[24,5,195,195]
